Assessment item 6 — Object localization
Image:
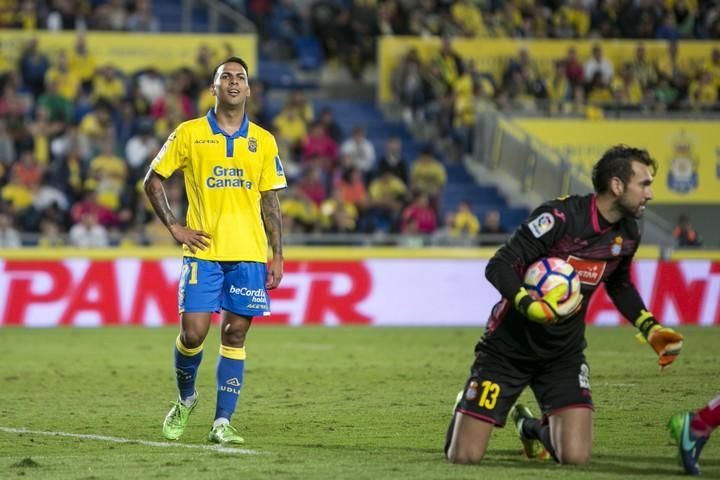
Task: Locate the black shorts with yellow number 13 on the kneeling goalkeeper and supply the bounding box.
[457,351,593,427]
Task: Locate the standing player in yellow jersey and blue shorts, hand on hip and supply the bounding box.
[145,57,287,444]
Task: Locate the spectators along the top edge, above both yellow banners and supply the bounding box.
[0,0,720,79]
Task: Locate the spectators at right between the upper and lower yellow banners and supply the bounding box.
[391,37,720,158]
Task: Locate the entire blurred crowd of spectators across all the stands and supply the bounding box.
[0,0,720,247]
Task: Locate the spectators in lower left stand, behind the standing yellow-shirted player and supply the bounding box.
[0,28,504,247]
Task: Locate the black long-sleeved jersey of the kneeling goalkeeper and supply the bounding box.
[476,195,645,360]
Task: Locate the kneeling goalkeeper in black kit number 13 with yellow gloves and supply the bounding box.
[445,145,683,464]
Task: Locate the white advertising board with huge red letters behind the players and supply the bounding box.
[0,258,720,327]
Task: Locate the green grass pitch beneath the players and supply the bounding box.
[0,326,720,480]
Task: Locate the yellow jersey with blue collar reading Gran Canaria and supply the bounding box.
[150,109,287,263]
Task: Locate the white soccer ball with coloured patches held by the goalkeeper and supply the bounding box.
[523,257,582,317]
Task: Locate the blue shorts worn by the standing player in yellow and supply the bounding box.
[178,257,270,317]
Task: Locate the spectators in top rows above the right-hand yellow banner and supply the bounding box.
[242,0,720,81]
